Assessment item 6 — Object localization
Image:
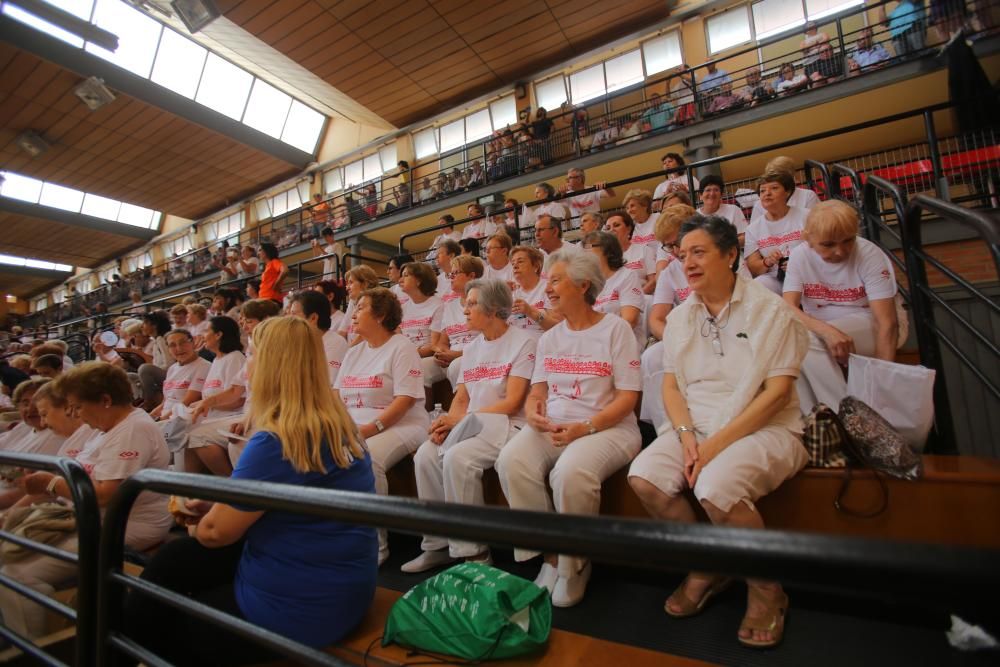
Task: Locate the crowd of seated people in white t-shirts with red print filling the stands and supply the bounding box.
[0,154,900,646]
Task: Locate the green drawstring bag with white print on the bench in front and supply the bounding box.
[382,563,552,660]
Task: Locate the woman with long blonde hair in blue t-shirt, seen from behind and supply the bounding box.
[124,318,376,665]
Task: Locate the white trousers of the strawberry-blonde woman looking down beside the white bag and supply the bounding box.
[795,313,875,414]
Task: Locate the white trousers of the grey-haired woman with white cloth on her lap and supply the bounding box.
[413,415,517,558]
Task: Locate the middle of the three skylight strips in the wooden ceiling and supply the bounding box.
[0,171,160,229]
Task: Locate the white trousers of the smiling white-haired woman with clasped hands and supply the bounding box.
[496,415,642,577]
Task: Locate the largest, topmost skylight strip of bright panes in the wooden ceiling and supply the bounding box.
[7,0,326,154]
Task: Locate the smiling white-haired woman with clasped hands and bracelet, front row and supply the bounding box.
[496,251,642,607]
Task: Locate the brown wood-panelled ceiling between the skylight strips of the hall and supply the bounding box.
[0,0,672,276]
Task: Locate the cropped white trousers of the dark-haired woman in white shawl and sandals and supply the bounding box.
[628,426,809,512]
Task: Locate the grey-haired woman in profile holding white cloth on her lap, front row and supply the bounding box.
[402,280,536,572]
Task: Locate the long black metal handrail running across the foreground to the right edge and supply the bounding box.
[97,470,1000,666]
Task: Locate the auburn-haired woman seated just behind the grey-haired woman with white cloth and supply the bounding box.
[422,255,483,389]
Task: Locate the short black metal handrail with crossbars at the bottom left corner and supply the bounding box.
[0,452,101,667]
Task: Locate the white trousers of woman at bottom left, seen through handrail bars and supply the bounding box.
[0,534,77,638]
